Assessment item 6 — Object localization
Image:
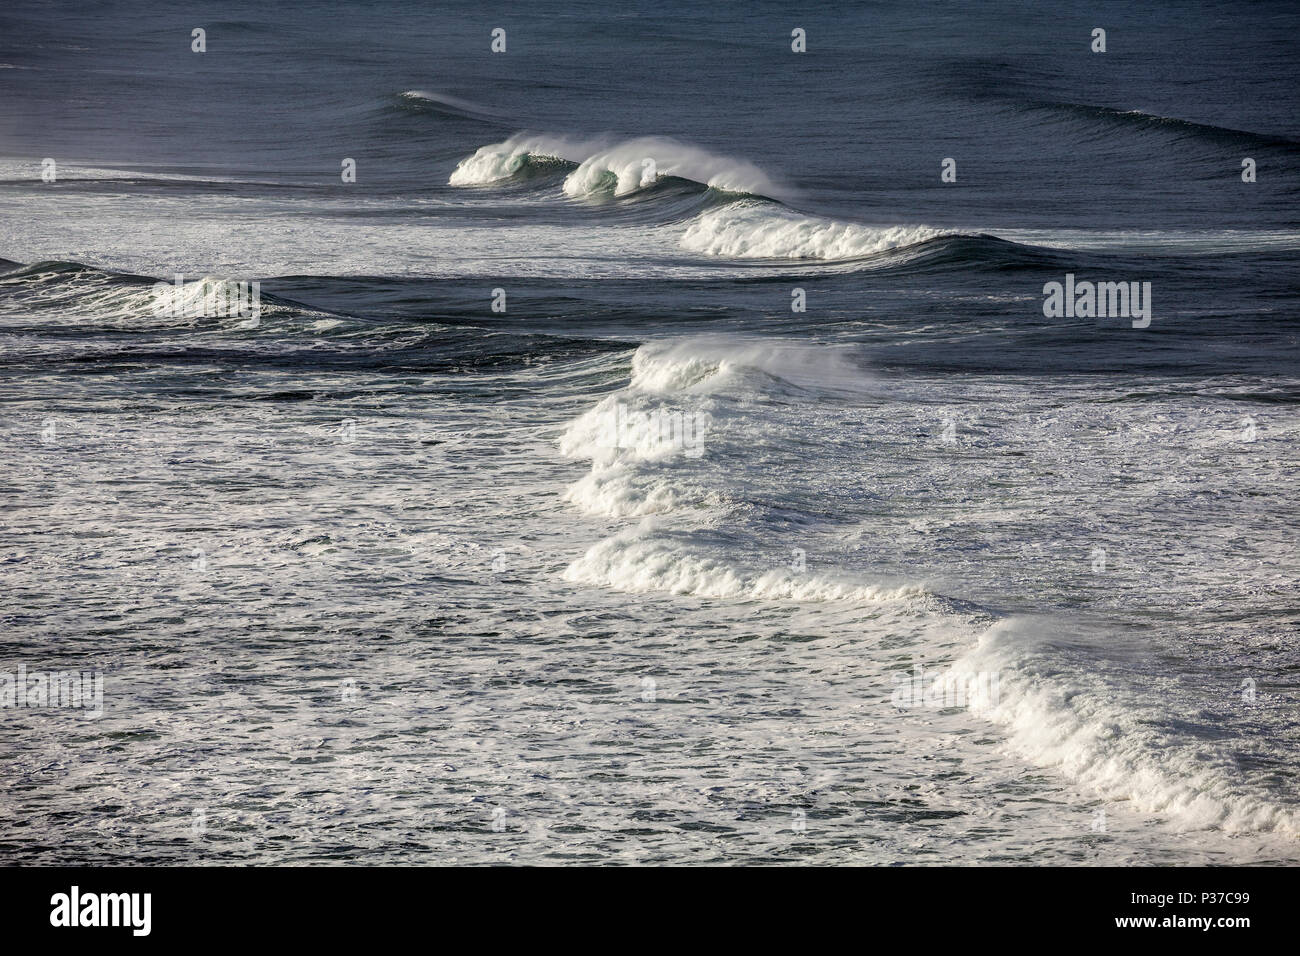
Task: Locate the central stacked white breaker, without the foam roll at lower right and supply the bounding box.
[559,339,927,604]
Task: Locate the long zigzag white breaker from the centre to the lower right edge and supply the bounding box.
[560,339,1300,838]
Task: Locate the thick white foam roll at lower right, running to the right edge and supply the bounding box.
[952,619,1300,838]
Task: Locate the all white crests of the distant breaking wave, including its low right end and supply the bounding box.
[449,133,954,260]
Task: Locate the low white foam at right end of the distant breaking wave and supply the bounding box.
[681,203,956,260]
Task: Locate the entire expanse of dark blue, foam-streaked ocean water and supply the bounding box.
[0,0,1300,865]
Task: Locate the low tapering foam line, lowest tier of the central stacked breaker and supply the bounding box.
[564,531,927,604]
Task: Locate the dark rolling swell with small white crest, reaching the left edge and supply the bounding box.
[0,260,627,375]
